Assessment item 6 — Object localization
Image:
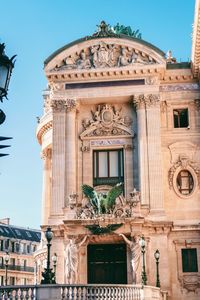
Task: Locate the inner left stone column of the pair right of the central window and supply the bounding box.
[133,94,149,205]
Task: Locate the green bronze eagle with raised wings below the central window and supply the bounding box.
[82,183,123,214]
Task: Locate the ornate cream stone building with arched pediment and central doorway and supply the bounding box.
[36,1,200,300]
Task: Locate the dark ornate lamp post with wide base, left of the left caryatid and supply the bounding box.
[41,227,56,284]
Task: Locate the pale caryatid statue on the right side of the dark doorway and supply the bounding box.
[119,233,141,284]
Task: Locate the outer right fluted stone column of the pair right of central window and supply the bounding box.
[145,94,164,214]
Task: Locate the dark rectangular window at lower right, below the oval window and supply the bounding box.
[181,248,198,272]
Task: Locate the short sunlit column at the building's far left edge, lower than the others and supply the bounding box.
[42,148,52,225]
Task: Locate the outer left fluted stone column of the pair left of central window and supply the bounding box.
[51,100,66,216]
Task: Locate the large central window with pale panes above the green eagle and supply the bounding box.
[93,149,124,186]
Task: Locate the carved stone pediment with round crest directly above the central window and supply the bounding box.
[80,104,132,138]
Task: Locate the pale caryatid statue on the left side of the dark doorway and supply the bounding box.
[65,235,88,284]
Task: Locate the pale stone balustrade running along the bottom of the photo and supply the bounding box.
[0,284,167,300]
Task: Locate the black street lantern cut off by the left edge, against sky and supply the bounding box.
[0,43,16,102]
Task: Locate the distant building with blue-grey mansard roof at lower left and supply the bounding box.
[0,219,41,285]
